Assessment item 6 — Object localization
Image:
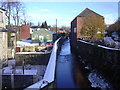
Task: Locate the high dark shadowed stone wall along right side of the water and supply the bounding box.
[77,41,120,88]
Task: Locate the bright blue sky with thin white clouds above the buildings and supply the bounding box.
[24,1,118,26]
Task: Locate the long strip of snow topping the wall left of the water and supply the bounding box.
[25,38,61,90]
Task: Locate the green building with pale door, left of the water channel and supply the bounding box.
[32,28,56,43]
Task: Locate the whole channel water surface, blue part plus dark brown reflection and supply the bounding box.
[56,40,89,88]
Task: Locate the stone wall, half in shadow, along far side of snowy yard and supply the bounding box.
[15,53,51,66]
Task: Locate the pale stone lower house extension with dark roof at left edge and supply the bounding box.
[0,28,16,65]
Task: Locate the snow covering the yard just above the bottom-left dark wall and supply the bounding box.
[3,65,46,76]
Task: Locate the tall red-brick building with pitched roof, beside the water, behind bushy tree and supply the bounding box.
[71,8,104,38]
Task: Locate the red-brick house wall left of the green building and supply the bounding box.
[19,25,30,40]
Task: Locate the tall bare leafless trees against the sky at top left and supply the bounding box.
[0,0,24,26]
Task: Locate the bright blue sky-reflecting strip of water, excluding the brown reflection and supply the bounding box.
[56,41,76,88]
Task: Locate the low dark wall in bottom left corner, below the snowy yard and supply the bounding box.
[2,75,35,89]
